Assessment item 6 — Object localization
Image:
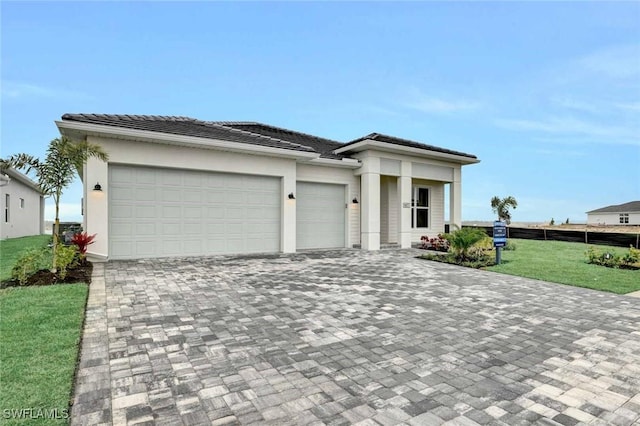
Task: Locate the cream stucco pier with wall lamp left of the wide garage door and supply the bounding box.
[83,157,109,262]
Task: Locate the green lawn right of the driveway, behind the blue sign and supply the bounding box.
[486,239,640,294]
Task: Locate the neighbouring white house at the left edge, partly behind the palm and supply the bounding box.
[0,169,44,239]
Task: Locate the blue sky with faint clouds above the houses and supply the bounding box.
[0,1,640,222]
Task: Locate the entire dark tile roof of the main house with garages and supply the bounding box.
[62,114,477,164]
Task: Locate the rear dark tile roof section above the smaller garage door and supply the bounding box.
[213,121,348,160]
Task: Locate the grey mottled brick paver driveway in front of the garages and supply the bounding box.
[72,250,640,425]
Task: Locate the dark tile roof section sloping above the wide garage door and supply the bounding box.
[62,114,315,152]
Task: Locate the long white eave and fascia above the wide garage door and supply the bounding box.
[56,120,320,160]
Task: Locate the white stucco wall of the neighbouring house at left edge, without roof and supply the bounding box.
[0,179,44,238]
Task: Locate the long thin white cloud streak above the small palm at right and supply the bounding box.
[496,117,640,146]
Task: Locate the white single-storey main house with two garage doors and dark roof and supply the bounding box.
[56,114,479,260]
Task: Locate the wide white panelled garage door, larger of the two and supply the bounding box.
[109,165,282,259]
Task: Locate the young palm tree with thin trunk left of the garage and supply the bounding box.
[0,136,108,272]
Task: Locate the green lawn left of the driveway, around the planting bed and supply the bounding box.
[0,235,88,425]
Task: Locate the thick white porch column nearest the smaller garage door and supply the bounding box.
[360,157,380,250]
